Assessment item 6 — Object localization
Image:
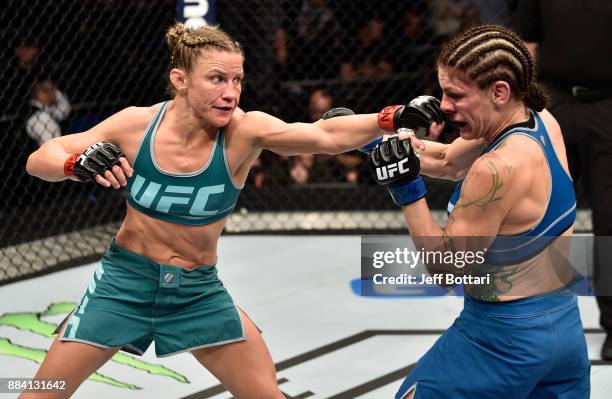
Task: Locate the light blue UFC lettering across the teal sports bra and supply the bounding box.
[130,175,225,216]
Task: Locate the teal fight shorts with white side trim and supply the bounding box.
[60,240,246,357]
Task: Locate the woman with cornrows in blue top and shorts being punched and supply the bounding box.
[371,26,590,399]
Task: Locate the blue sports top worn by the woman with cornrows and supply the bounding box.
[447,110,576,265]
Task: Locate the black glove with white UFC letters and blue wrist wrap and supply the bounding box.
[369,136,427,206]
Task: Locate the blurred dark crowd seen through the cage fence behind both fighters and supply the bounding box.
[0,0,515,195]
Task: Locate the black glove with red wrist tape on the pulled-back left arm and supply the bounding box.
[64,141,125,181]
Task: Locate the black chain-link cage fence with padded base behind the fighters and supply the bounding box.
[0,0,590,281]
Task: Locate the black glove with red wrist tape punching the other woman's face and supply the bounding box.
[378,96,457,138]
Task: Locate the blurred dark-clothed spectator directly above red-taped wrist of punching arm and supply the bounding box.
[340,16,393,81]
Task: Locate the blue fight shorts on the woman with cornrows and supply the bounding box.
[395,291,591,399]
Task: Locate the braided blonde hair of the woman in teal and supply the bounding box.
[166,22,244,95]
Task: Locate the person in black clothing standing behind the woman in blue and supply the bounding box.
[515,0,612,360]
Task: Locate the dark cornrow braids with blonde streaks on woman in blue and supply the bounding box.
[436,25,546,111]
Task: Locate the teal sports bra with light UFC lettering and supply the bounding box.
[127,102,242,226]
